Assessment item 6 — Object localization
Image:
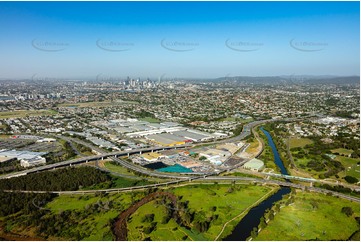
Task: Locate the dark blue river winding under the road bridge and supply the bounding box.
[223,127,291,241]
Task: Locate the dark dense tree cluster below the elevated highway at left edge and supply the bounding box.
[0,166,111,191]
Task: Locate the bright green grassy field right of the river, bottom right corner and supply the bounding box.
[255,192,360,241]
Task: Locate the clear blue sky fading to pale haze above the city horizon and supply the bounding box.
[0,2,360,79]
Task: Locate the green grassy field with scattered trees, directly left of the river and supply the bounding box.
[128,184,275,241]
